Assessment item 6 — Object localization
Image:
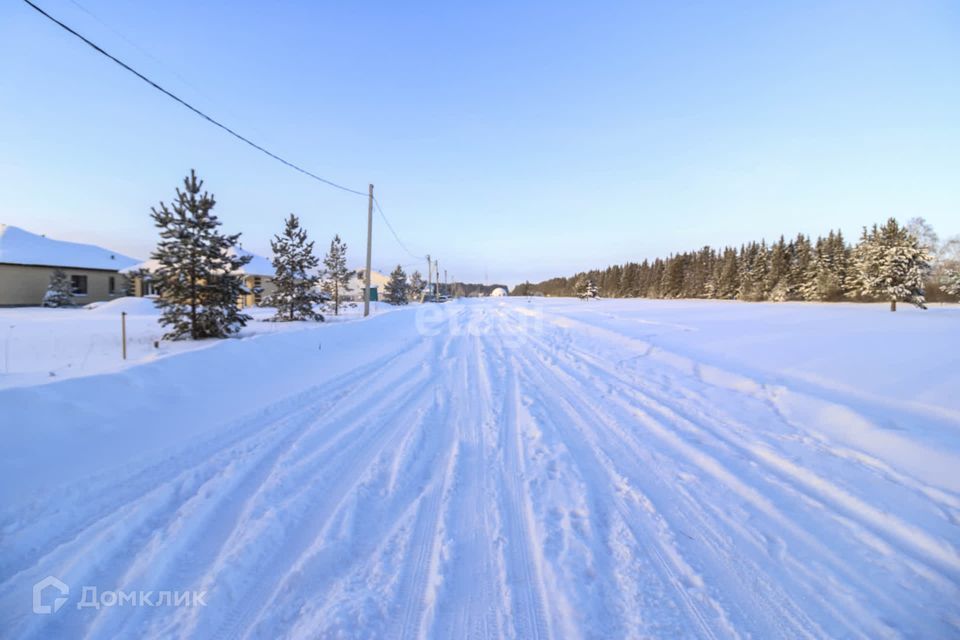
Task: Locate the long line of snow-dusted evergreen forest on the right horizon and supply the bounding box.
[513,218,960,309]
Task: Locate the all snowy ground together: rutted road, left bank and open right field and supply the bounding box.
[0,298,960,638]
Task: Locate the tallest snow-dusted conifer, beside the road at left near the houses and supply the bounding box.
[151,169,250,340]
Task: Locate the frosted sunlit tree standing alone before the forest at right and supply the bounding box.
[854,218,930,311]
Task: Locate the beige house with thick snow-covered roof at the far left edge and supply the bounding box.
[0,224,137,307]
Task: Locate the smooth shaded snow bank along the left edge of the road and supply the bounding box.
[0,310,416,505]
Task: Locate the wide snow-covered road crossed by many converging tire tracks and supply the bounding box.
[0,301,960,638]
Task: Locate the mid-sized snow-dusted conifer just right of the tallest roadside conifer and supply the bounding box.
[264,213,323,322]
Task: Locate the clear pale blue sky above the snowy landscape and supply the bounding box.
[0,0,960,284]
